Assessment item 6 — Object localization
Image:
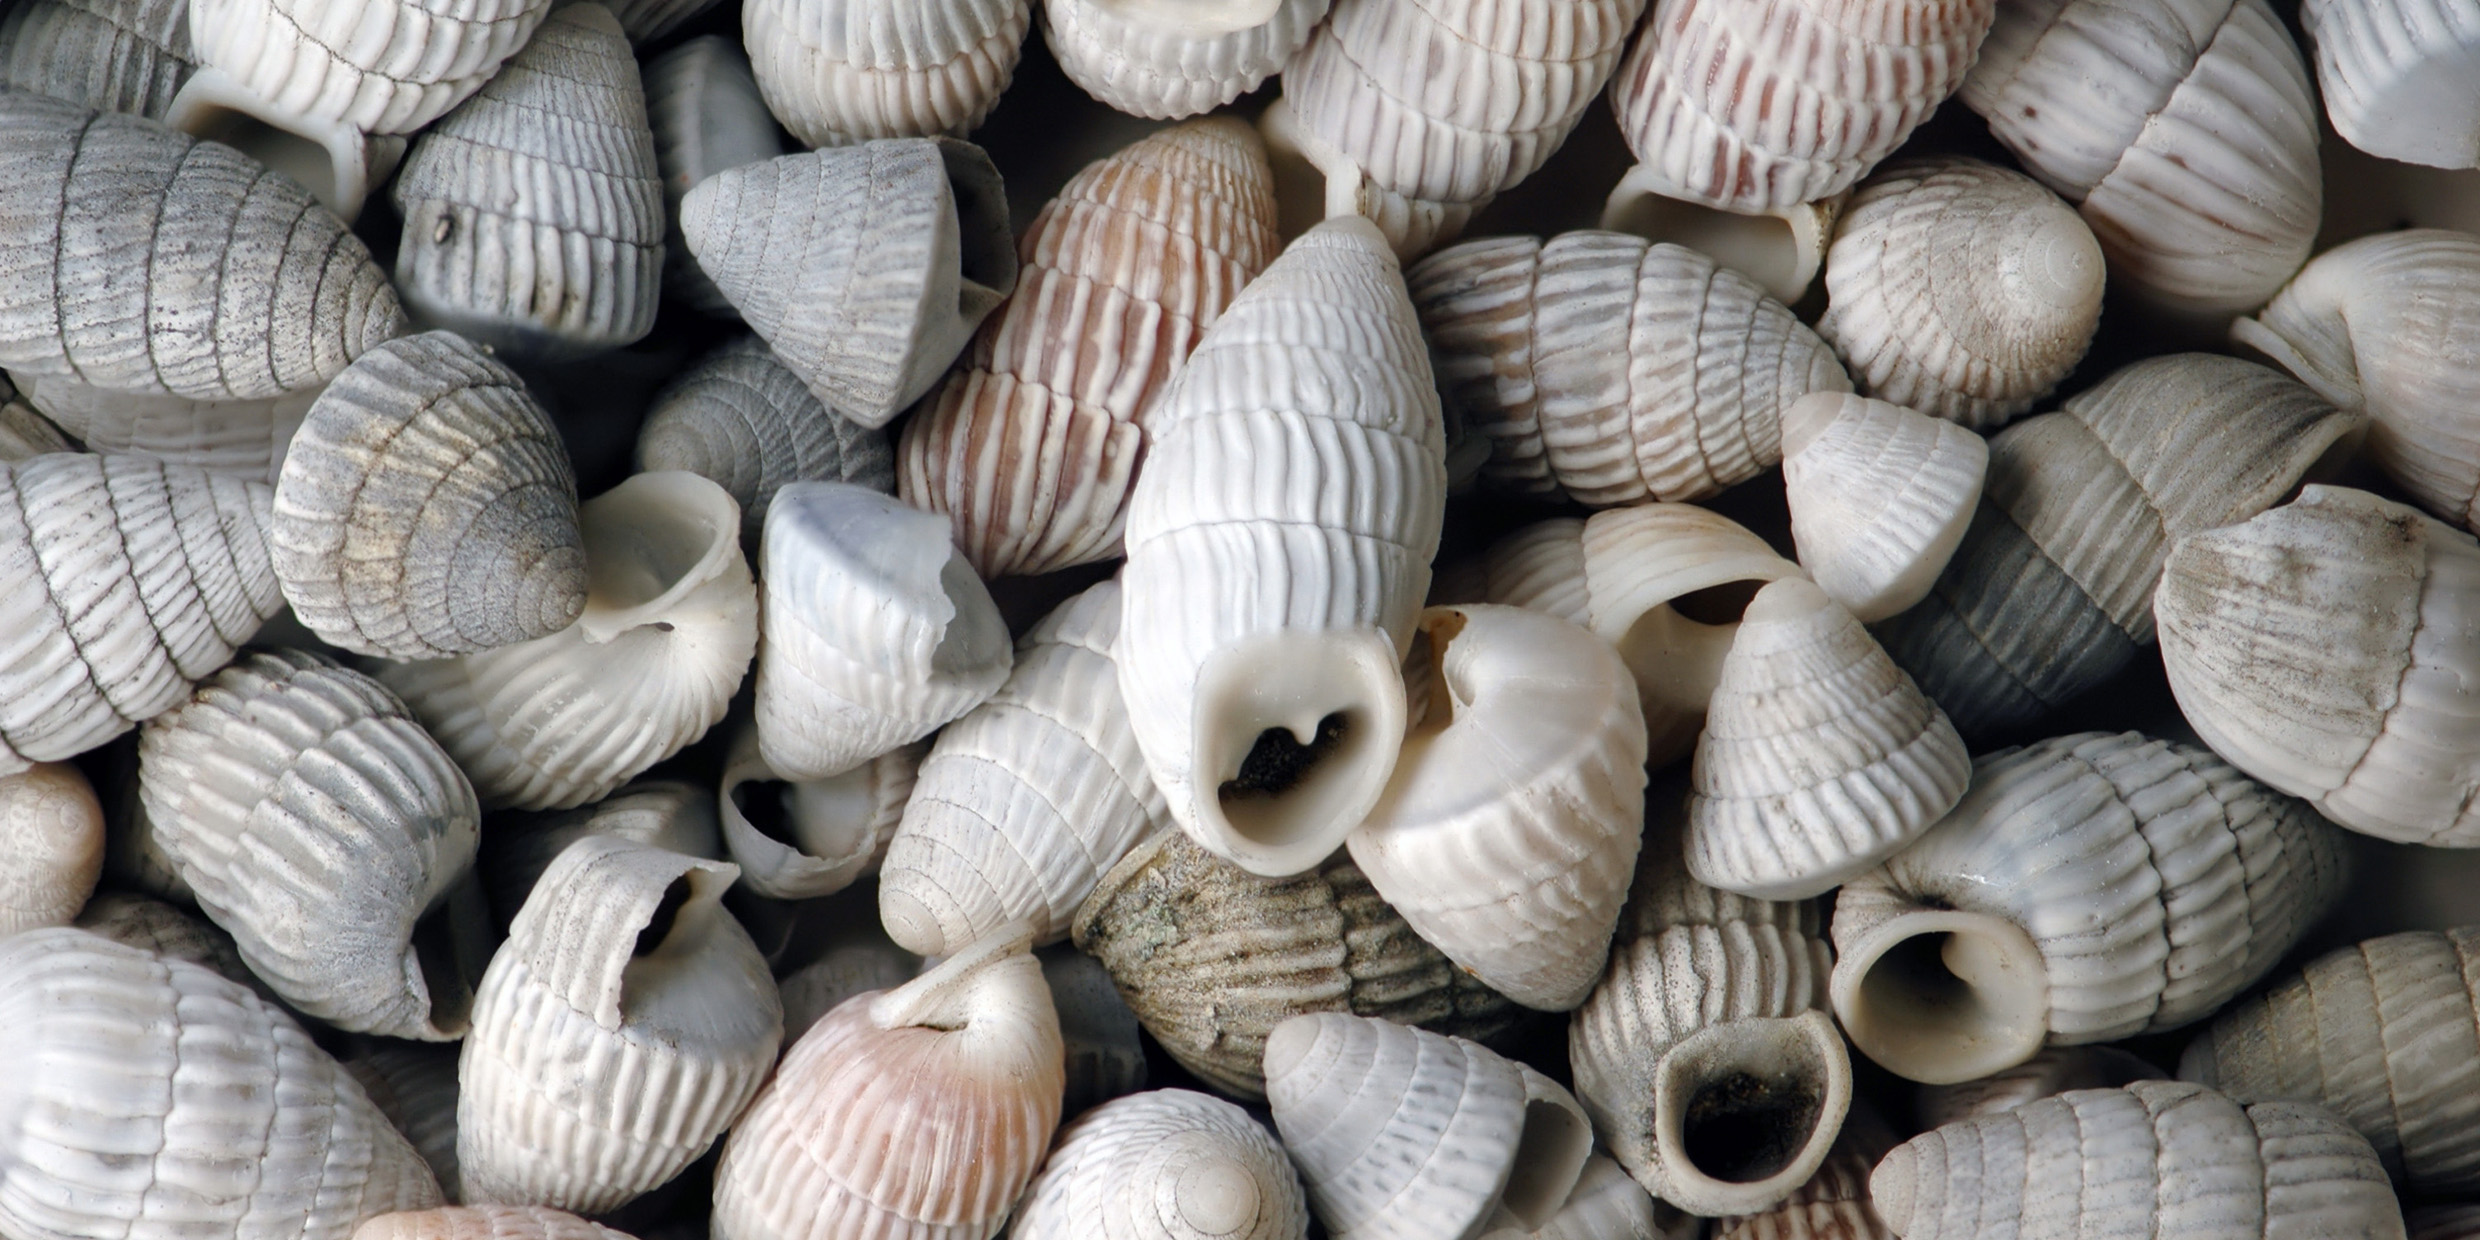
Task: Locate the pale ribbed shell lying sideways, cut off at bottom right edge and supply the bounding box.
[1870,1081,2403,1240]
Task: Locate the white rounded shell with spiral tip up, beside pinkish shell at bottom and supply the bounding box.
[1009,1089,1309,1240]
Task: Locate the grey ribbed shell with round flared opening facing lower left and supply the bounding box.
[1833,732,2346,1084]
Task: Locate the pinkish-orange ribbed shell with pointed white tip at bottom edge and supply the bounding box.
[714,932,1061,1240]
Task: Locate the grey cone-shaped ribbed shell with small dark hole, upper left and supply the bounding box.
[386,0,667,362]
